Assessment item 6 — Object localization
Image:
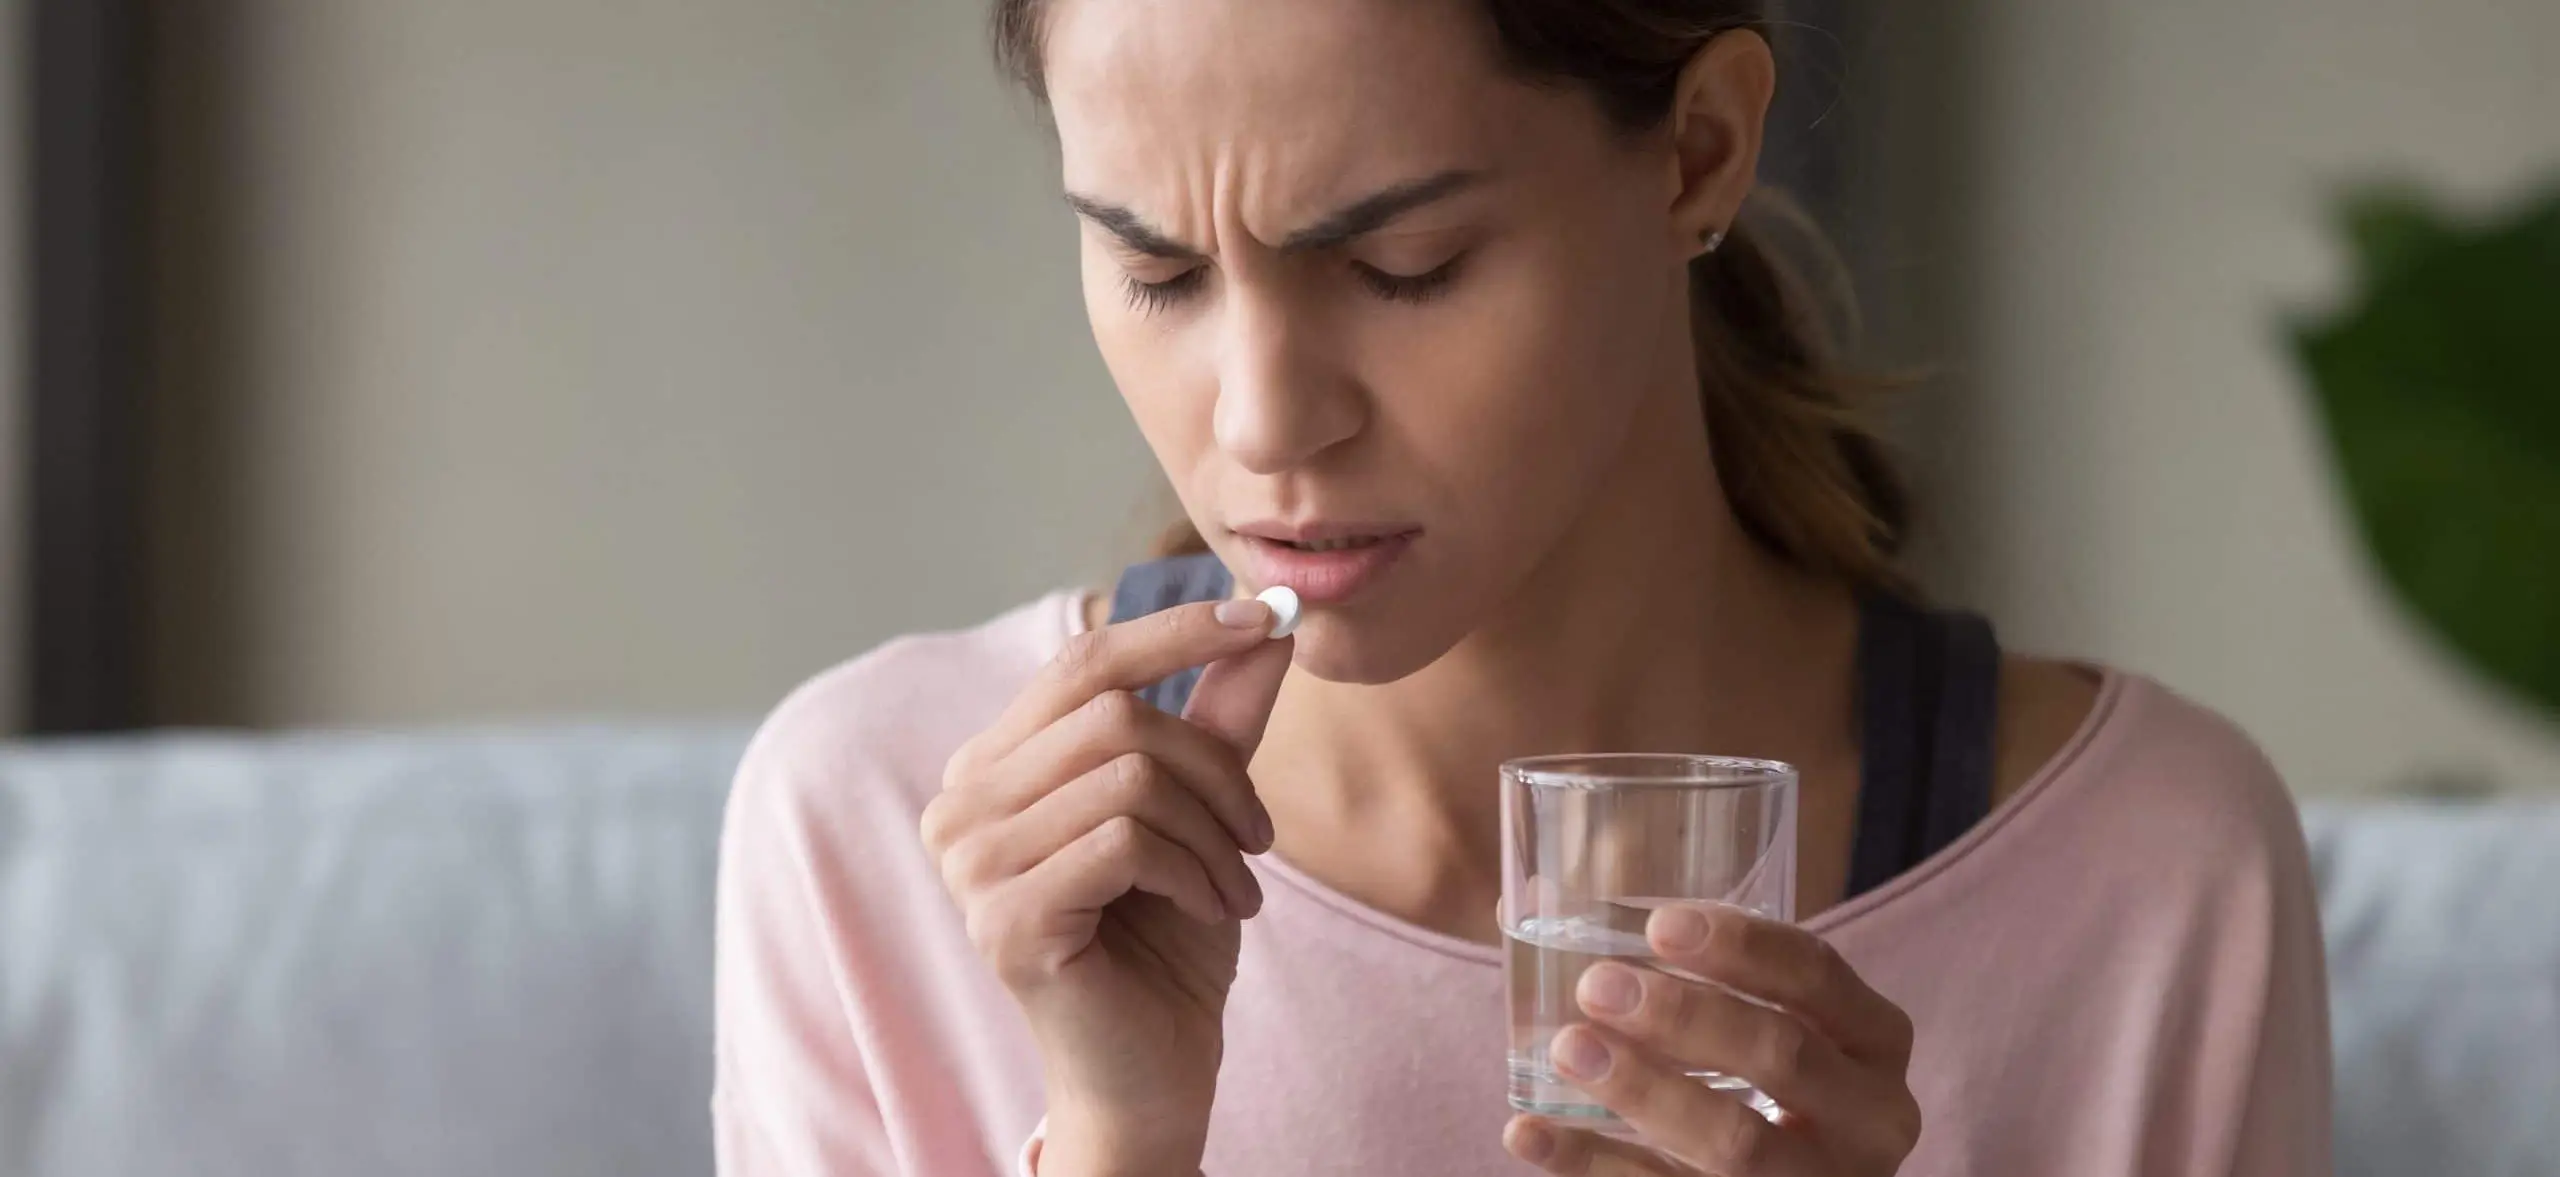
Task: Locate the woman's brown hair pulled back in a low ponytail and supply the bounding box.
[993,0,1910,589]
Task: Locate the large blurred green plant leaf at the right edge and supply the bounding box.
[2294,189,2560,716]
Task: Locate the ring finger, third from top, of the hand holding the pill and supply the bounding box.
[945,752,1262,919]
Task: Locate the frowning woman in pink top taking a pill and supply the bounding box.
[712,0,2327,1177]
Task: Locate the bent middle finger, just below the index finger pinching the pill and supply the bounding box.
[970,691,1270,855]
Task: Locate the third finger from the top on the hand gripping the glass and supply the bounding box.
[1549,1026,1820,1177]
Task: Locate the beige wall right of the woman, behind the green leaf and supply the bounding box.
[1905,0,2560,791]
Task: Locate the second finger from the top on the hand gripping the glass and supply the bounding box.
[1574,965,1889,1126]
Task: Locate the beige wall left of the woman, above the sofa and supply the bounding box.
[154,0,1152,724]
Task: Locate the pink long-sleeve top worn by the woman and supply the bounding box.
[712,594,2330,1177]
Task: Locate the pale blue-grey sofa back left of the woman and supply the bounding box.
[0,727,748,1177]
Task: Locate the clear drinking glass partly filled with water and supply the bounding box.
[1503,755,1797,1136]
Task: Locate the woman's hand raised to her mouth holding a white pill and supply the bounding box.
[922,601,1293,1174]
